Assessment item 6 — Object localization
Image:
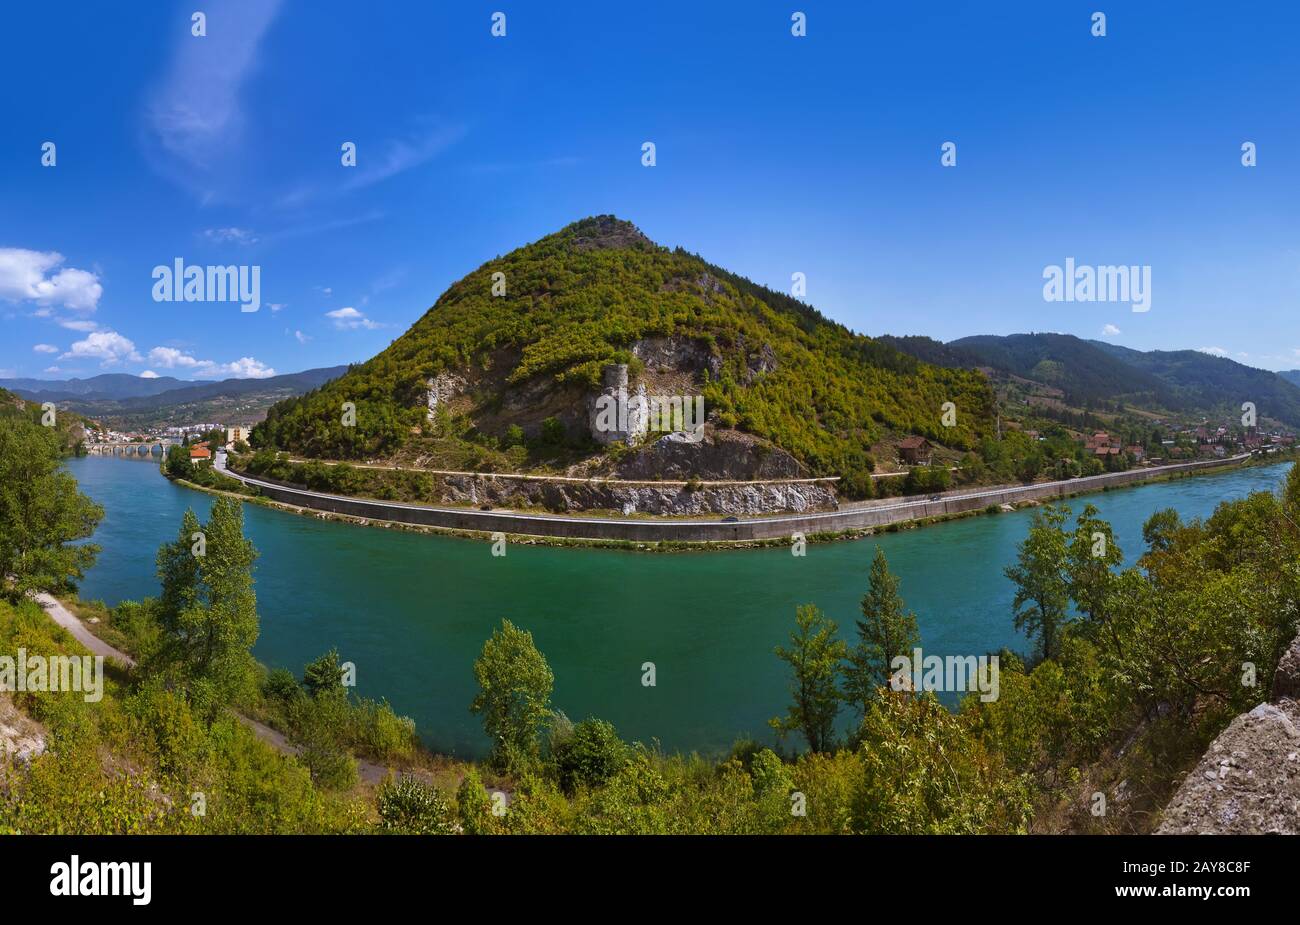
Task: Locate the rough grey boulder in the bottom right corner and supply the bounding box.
[1157,637,1300,835]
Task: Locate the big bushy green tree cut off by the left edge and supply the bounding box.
[0,417,104,599]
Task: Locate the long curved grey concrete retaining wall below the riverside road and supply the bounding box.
[226,456,1248,542]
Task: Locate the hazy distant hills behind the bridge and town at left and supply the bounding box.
[0,366,348,429]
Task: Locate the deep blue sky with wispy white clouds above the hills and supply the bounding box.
[0,0,1300,378]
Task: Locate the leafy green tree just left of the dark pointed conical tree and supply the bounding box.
[770,604,848,752]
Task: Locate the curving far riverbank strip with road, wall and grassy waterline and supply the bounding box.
[177,453,1295,552]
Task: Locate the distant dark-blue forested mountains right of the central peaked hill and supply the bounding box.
[879,334,1300,426]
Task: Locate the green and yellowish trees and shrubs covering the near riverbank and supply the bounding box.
[0,420,1300,834]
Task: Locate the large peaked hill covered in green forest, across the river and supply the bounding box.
[254,216,992,474]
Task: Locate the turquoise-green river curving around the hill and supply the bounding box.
[68,456,1287,757]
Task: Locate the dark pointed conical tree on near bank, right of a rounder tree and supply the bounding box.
[844,546,920,716]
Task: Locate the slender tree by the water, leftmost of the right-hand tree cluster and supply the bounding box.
[1004,504,1070,659]
